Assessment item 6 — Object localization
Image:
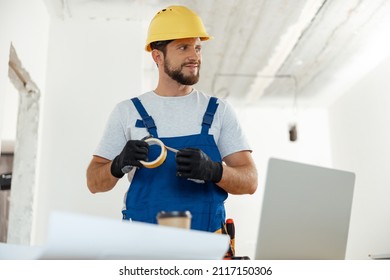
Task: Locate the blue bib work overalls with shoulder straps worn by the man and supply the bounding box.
[122,97,228,232]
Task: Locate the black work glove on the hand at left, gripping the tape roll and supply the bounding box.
[111,140,149,178]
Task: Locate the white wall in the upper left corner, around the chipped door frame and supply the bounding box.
[0,0,49,151]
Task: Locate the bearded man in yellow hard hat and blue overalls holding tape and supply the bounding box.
[87,6,257,232]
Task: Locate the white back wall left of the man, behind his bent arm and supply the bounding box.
[35,20,144,243]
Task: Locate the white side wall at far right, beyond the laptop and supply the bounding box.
[329,55,390,259]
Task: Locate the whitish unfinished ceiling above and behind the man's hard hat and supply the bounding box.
[44,0,390,107]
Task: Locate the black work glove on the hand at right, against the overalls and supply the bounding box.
[176,148,222,183]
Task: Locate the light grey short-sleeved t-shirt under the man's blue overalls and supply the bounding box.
[94,89,250,160]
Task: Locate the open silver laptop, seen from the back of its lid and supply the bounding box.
[255,158,355,260]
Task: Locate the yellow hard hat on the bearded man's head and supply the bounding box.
[145,6,212,52]
